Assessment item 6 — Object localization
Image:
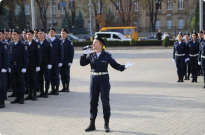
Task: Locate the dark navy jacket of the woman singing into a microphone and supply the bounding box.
[80,50,125,72]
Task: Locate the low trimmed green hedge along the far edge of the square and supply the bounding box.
[73,40,175,47]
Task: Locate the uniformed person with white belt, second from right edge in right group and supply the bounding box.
[188,31,199,82]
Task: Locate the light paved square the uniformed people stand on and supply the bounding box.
[0,48,205,135]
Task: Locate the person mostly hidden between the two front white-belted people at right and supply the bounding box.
[184,33,191,80]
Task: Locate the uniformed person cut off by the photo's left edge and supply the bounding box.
[0,30,9,108]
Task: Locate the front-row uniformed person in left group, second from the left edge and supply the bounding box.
[9,29,28,104]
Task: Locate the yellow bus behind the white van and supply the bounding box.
[100,26,138,41]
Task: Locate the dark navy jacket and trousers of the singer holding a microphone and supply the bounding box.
[80,50,125,119]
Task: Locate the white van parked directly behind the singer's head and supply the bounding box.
[95,32,131,41]
